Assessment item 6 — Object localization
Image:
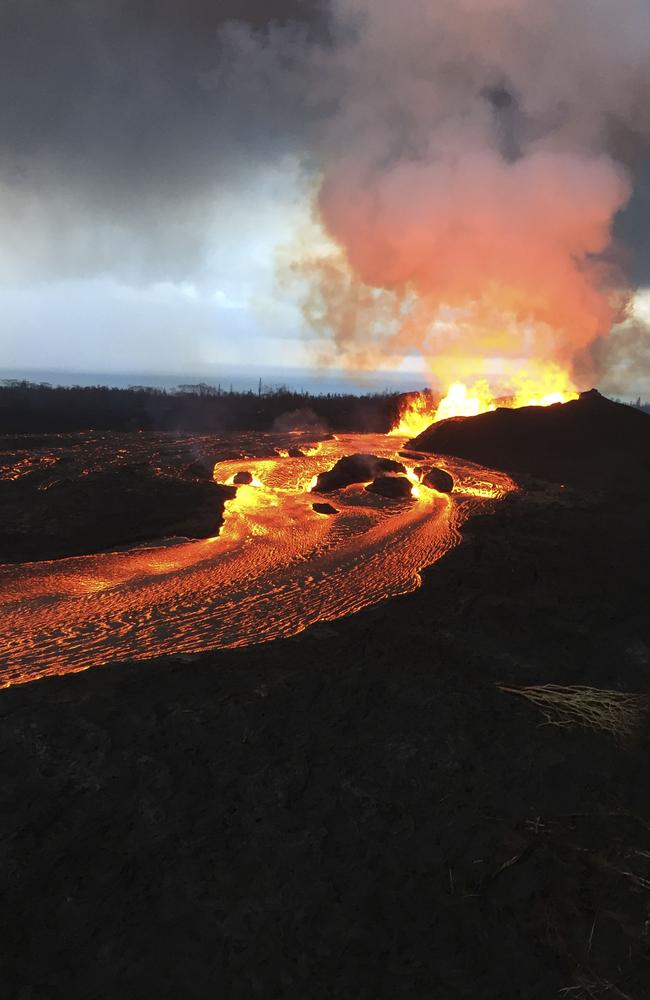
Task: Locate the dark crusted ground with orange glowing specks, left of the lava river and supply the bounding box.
[0,431,330,562]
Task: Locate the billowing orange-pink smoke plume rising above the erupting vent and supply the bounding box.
[286,0,650,383]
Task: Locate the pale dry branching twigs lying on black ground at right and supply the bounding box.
[499,684,650,739]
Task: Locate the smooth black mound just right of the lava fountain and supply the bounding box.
[410,389,650,490]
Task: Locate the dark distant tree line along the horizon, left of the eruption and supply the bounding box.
[0,380,412,434]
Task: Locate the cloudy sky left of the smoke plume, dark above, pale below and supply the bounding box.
[0,0,334,373]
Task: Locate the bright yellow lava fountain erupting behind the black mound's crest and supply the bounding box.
[390,364,578,437]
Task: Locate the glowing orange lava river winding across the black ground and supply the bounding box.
[0,435,514,685]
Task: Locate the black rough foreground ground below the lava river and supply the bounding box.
[0,482,650,1000]
